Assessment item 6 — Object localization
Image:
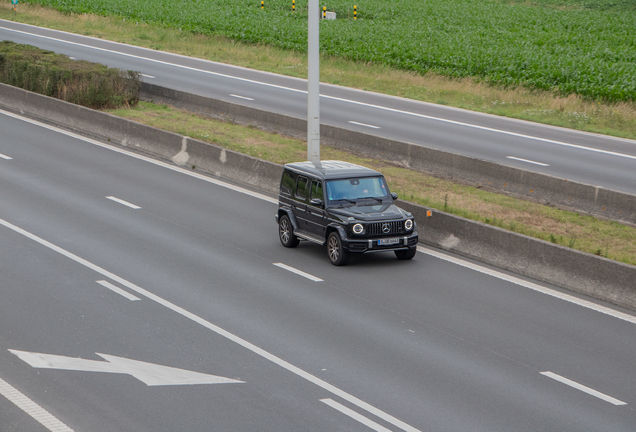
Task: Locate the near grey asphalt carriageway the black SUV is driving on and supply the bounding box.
[0,115,636,431]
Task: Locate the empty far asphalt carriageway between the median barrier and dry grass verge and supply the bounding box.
[0,21,636,193]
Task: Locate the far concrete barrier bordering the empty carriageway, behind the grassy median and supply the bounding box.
[141,83,636,224]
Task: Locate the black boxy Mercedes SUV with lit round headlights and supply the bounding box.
[276,161,417,265]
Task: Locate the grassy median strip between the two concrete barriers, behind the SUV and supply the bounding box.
[108,102,636,265]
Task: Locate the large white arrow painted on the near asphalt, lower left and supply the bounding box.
[9,350,245,386]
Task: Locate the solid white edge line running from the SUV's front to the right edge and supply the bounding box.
[417,246,636,324]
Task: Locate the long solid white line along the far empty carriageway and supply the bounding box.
[0,22,636,160]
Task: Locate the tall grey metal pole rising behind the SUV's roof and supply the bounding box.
[307,0,320,162]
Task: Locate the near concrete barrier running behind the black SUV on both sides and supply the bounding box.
[0,84,636,310]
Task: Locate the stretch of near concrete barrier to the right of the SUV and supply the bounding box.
[397,201,636,310]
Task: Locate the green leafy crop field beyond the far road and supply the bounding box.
[21,0,636,102]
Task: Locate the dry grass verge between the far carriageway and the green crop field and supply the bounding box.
[0,3,636,139]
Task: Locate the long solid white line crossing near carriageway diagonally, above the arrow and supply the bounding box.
[0,219,421,432]
